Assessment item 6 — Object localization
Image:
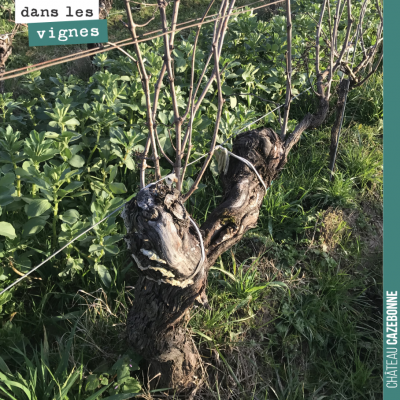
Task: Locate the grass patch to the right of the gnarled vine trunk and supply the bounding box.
[185,123,382,399]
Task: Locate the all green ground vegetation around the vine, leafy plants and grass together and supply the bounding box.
[0,1,382,400]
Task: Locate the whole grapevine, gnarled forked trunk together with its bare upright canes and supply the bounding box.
[119,0,383,388]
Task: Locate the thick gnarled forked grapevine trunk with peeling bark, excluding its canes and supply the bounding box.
[123,129,286,388]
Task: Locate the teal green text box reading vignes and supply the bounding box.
[28,19,108,47]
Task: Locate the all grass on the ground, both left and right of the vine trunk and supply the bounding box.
[0,0,382,400]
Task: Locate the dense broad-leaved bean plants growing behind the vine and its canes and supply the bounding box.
[0,6,380,288]
